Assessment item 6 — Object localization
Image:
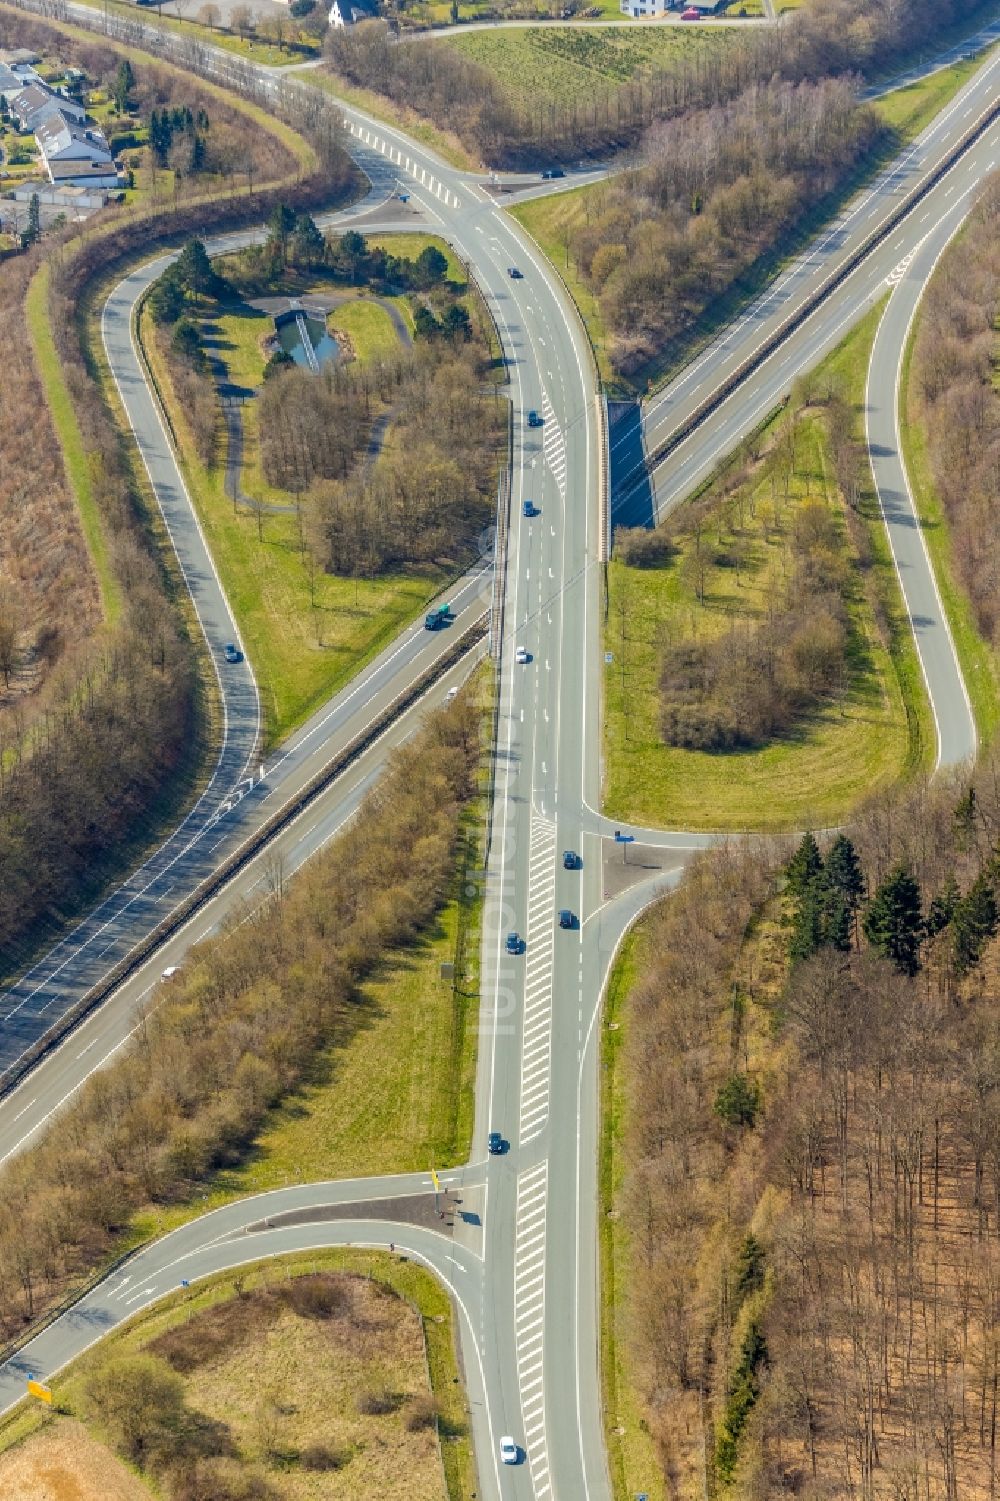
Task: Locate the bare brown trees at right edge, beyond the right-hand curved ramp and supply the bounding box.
[911,176,1000,651]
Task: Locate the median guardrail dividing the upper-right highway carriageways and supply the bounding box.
[620,89,1000,504]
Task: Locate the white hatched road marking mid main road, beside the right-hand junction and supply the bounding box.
[521,815,556,1145]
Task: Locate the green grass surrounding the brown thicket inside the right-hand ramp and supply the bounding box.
[604,298,934,830]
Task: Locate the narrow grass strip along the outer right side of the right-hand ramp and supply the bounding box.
[899,267,1000,747]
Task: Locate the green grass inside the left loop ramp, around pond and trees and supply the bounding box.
[143,236,471,744]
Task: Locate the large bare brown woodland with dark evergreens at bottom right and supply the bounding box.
[610,758,1000,1501]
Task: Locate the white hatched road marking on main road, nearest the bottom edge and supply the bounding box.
[514,1162,553,1501]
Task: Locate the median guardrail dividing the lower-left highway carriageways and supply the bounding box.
[0,614,488,1097]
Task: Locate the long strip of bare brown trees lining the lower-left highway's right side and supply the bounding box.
[0,699,480,1337]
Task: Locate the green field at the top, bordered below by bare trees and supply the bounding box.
[447,27,733,107]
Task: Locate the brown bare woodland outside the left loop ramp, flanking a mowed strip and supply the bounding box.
[0,17,351,973]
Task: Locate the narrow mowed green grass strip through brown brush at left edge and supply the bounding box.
[24,266,122,624]
